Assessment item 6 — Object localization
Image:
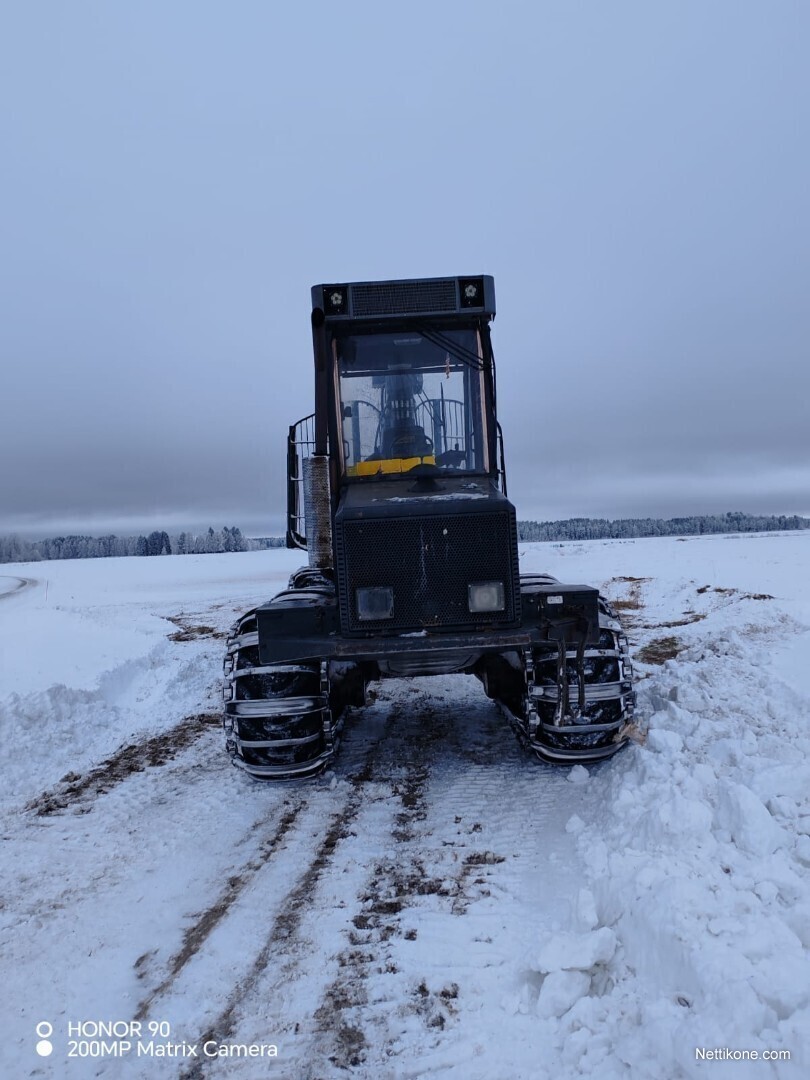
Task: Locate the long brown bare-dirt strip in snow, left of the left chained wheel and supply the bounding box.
[25,713,221,818]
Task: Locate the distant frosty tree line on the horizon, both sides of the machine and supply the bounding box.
[0,511,810,563]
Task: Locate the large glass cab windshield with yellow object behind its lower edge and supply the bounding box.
[336,329,489,478]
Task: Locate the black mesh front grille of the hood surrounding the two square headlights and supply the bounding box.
[336,513,515,633]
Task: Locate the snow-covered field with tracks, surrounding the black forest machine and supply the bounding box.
[0,532,810,1080]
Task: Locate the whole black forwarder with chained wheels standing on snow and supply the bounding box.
[225,276,635,780]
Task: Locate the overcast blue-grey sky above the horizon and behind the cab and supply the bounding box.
[0,0,810,535]
